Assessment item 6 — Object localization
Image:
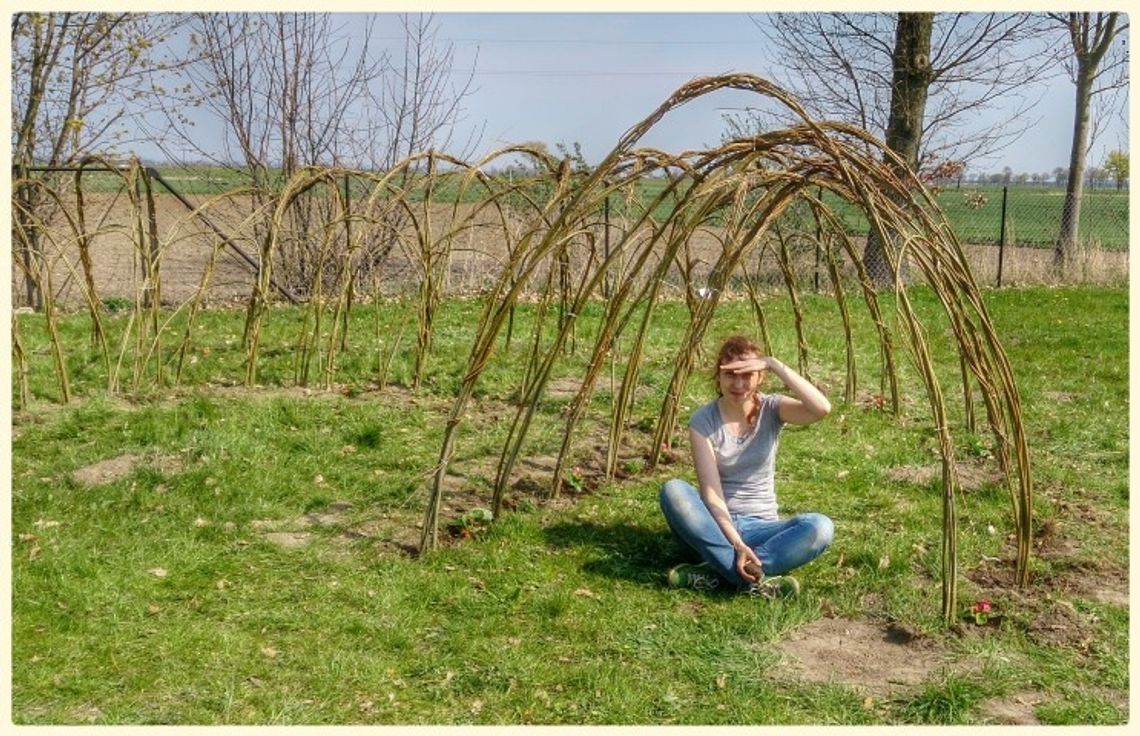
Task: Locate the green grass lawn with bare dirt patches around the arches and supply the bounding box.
[11,288,1130,725]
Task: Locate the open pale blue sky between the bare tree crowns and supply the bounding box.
[408,13,1127,177]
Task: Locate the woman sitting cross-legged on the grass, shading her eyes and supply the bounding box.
[661,336,834,598]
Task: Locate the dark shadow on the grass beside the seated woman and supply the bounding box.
[544,522,694,587]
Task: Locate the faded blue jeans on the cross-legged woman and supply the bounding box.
[661,479,834,588]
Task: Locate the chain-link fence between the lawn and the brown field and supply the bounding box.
[13,166,1129,306]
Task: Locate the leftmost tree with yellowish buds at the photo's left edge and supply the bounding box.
[11,13,185,308]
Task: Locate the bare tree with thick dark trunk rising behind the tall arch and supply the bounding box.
[758,13,1048,286]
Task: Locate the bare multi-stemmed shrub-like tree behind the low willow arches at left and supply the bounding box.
[144,13,473,293]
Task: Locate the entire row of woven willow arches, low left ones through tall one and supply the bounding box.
[14,75,1032,622]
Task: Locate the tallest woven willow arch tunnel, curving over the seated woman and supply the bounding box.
[412,75,1032,622]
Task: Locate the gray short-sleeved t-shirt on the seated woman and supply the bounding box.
[689,394,783,520]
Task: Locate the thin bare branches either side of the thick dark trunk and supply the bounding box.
[754,13,1052,172]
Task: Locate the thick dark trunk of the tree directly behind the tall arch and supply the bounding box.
[863,13,934,288]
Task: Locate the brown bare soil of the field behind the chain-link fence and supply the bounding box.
[20,194,1129,309]
